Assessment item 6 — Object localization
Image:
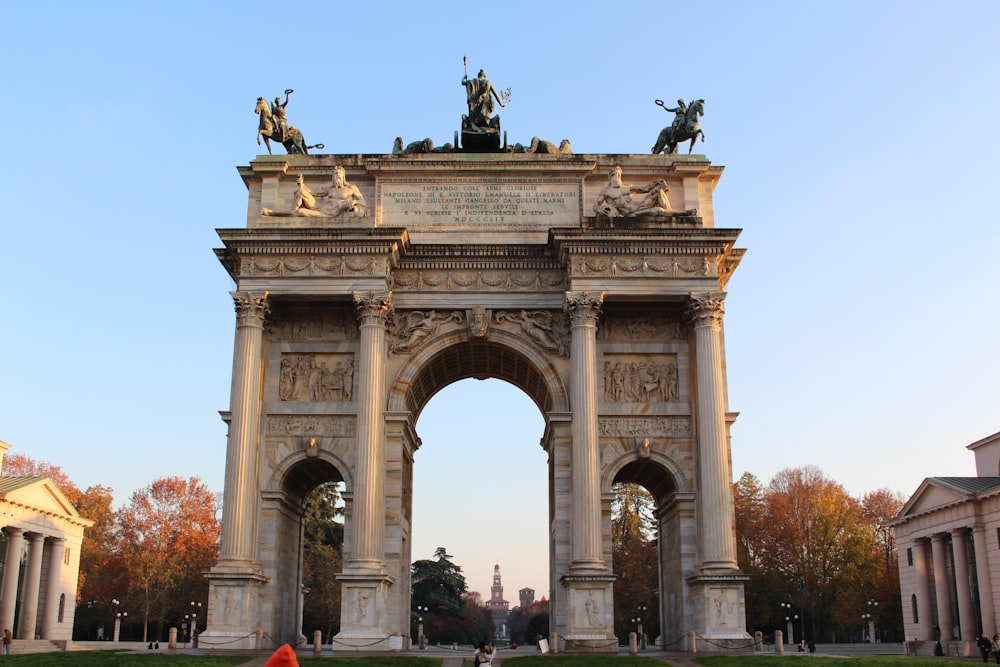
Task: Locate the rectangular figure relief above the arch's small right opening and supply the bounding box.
[604,354,678,403]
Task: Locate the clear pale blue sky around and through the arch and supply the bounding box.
[0,0,1000,601]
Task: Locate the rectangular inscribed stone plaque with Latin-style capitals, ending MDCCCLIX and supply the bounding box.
[376,178,583,227]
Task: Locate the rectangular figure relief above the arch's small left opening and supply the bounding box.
[278,354,354,403]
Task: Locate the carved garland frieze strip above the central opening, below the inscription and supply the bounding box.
[391,269,569,292]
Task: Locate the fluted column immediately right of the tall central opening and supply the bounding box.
[565,292,605,570]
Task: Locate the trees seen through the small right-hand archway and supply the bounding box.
[611,483,660,637]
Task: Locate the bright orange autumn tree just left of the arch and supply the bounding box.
[116,477,220,641]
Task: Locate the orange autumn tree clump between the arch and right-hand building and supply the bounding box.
[734,466,902,641]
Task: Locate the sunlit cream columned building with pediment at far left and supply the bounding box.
[0,442,94,648]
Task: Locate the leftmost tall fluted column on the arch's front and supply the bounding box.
[219,292,268,565]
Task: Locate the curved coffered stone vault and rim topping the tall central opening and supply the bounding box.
[388,329,569,423]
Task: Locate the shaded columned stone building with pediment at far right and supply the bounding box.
[891,433,1000,655]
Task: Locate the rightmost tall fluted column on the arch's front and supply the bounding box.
[688,293,738,573]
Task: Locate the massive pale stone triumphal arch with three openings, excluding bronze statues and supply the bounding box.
[202,85,747,651]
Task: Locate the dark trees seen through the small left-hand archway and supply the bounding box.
[302,482,344,638]
